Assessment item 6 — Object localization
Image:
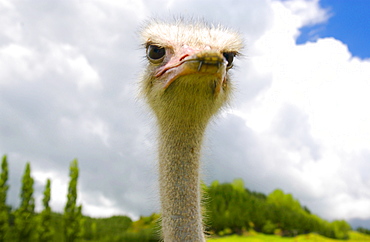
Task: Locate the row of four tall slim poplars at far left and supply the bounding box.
[0,155,83,242]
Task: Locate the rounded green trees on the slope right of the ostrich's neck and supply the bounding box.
[205,179,351,239]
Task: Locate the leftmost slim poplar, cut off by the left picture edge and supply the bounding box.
[0,155,9,242]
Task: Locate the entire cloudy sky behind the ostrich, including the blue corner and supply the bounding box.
[0,0,370,226]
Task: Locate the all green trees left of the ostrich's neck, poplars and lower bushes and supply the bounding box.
[0,155,160,242]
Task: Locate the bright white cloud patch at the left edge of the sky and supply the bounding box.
[0,41,101,89]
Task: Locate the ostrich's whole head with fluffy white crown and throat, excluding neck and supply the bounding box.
[142,22,242,121]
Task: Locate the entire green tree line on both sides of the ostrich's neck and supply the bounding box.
[0,156,369,242]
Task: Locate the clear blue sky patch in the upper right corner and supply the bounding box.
[297,0,370,58]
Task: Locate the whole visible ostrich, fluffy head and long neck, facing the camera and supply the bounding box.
[141,20,242,242]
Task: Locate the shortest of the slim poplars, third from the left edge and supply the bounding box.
[39,179,54,242]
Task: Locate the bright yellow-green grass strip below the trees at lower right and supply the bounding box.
[207,231,370,242]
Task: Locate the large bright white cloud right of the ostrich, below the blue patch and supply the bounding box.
[225,1,370,219]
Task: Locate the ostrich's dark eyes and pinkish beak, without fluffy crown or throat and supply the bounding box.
[147,44,236,96]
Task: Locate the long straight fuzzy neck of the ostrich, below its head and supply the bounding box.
[159,122,206,242]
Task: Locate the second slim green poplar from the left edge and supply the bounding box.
[15,163,35,242]
